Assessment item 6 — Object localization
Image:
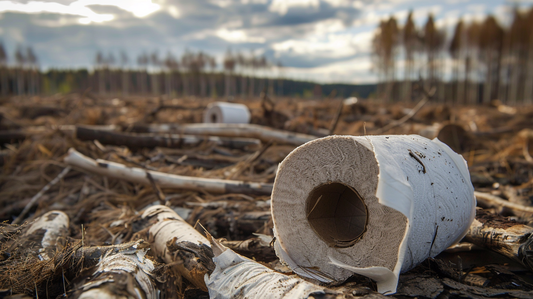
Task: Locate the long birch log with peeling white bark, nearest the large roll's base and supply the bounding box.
[136,205,356,298]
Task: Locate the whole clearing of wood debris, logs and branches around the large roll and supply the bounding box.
[0,93,533,298]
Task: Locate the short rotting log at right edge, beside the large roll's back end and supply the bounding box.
[464,209,533,269]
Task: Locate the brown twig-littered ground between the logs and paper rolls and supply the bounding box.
[0,93,533,298]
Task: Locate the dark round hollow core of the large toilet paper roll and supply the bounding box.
[306,183,368,247]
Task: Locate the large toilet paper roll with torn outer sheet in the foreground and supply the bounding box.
[272,135,476,294]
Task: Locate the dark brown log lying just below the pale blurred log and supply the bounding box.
[76,126,260,149]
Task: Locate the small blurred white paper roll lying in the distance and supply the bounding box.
[204,102,250,124]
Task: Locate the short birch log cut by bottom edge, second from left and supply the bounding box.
[72,240,160,299]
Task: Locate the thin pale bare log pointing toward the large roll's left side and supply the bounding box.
[64,148,272,195]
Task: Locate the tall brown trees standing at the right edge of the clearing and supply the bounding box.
[372,8,533,104]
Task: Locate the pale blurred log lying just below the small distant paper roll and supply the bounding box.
[125,124,317,145]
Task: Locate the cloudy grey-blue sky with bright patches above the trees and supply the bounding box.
[0,0,533,83]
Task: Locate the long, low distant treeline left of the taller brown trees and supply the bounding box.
[0,44,376,98]
